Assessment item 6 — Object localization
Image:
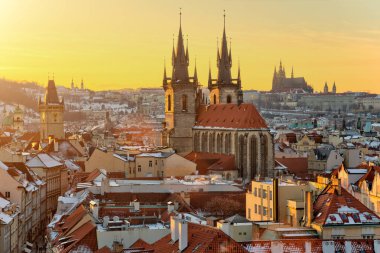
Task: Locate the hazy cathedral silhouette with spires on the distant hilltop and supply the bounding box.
[272,61,313,93]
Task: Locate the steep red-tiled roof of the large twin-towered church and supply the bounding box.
[195,104,268,129]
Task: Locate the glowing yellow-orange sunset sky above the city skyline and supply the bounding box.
[0,0,380,93]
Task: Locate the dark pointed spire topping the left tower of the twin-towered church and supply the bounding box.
[172,9,189,83]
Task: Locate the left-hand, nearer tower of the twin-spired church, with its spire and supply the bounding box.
[162,12,201,153]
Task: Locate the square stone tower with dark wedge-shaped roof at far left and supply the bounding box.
[38,80,65,140]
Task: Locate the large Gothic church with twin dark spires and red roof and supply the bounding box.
[162,14,274,182]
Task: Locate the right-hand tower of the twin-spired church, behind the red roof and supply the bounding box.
[208,11,243,104]
